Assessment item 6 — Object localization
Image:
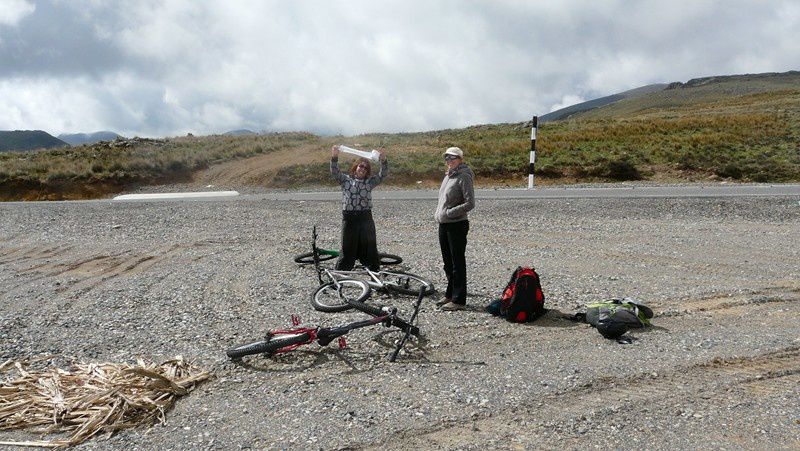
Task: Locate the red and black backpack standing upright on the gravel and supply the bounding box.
[486,266,545,323]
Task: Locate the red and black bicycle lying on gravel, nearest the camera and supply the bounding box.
[226,290,424,362]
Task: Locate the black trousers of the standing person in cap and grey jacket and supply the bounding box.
[439,221,469,304]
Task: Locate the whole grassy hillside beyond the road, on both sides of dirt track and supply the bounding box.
[0,72,800,199]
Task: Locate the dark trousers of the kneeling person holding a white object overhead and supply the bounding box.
[336,210,380,271]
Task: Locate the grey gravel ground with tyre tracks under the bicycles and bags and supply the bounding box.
[0,192,800,450]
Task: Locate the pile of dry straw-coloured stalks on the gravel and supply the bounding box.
[0,357,210,447]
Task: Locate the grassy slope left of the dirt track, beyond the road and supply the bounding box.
[0,133,317,200]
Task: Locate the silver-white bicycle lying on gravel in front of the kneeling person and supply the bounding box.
[311,227,434,312]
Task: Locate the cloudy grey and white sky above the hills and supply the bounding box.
[0,0,800,137]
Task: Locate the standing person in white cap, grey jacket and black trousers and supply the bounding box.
[434,147,475,311]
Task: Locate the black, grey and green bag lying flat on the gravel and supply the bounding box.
[585,298,653,338]
